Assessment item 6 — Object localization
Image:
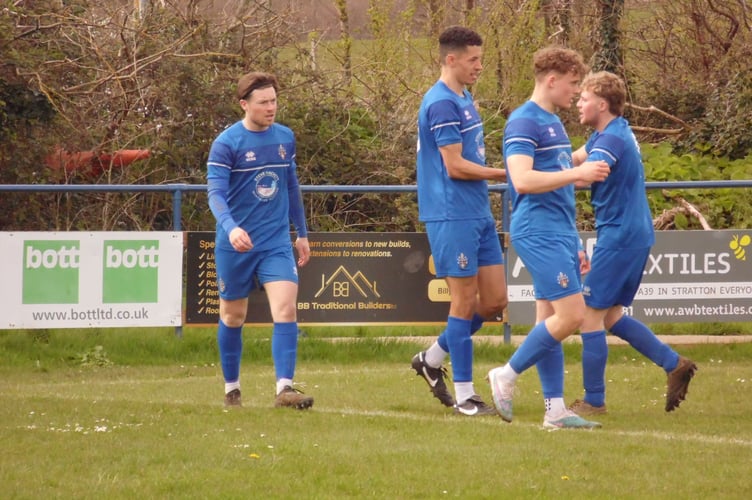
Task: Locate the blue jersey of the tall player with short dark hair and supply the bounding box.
[416,81,491,222]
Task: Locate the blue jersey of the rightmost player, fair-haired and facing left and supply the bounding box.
[585,116,655,249]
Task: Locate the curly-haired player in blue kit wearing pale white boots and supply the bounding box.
[488,47,609,429]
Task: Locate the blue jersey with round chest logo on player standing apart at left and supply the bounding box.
[207,121,306,251]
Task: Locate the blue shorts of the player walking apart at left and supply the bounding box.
[214,245,298,300]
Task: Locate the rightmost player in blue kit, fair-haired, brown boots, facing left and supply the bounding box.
[570,71,697,416]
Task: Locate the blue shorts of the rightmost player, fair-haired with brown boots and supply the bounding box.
[582,244,650,309]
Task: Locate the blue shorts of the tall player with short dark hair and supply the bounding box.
[426,217,504,278]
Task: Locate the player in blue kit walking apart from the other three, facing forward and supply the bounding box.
[207,72,313,409]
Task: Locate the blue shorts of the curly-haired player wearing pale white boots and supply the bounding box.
[512,234,582,301]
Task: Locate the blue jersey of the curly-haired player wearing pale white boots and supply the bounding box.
[503,101,577,239]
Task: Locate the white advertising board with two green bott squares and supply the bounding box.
[0,231,183,329]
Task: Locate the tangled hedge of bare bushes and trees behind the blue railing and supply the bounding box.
[0,0,752,231]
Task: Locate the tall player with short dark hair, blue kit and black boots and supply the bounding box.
[412,26,507,416]
